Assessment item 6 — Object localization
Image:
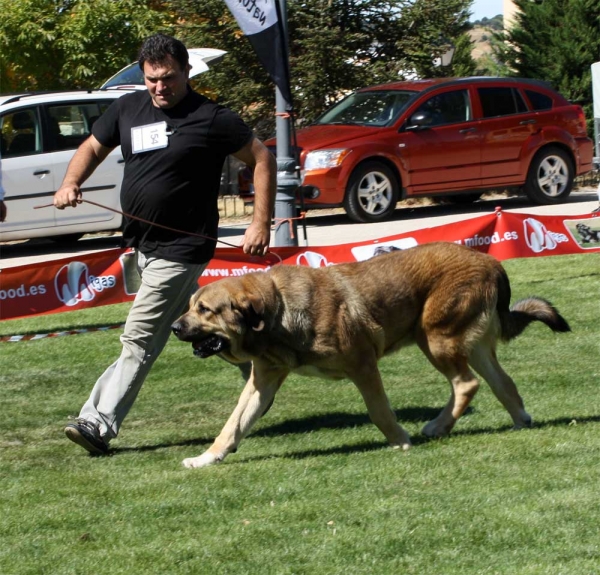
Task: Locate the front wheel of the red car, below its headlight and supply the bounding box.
[344,162,399,223]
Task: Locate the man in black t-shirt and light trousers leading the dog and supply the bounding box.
[54,34,277,454]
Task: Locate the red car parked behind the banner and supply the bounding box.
[241,77,593,222]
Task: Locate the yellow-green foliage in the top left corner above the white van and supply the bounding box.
[0,0,171,92]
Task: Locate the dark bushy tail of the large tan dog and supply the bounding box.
[497,266,571,341]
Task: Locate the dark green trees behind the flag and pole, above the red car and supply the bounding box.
[171,0,471,135]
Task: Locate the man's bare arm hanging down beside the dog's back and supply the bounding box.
[234,138,277,256]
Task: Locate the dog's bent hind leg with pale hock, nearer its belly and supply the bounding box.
[418,337,479,437]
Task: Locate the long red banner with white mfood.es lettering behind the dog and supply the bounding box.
[0,210,600,320]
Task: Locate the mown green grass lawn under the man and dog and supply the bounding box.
[0,254,600,575]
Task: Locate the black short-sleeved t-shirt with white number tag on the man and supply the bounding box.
[92,88,252,263]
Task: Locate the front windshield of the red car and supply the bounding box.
[316,90,418,126]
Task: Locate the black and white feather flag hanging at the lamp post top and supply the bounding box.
[225,0,292,108]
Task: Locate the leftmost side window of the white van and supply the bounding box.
[0,108,42,158]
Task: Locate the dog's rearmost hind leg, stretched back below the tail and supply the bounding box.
[469,340,532,429]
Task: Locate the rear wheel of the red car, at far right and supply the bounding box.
[524,147,575,204]
